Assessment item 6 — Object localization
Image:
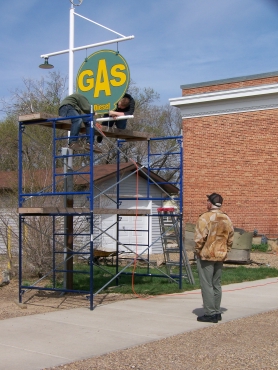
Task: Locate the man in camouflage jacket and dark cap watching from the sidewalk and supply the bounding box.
[194,193,234,323]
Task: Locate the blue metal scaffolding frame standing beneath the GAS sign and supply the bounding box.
[18,113,191,310]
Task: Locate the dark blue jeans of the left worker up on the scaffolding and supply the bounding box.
[59,104,91,144]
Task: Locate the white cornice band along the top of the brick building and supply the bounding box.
[169,84,278,118]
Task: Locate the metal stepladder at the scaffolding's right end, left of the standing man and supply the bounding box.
[157,207,195,284]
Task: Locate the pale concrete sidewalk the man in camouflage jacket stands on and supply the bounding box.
[0,278,278,370]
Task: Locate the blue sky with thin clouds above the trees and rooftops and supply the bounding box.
[0,0,278,111]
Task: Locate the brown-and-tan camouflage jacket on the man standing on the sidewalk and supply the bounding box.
[194,209,234,261]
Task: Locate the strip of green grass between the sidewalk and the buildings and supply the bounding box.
[46,265,278,295]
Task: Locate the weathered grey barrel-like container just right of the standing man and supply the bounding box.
[225,228,253,263]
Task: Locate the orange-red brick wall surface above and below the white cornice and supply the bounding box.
[183,77,278,237]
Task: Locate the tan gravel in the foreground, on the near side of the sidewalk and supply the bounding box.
[48,310,278,370]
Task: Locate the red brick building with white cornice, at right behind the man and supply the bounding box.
[170,72,278,237]
